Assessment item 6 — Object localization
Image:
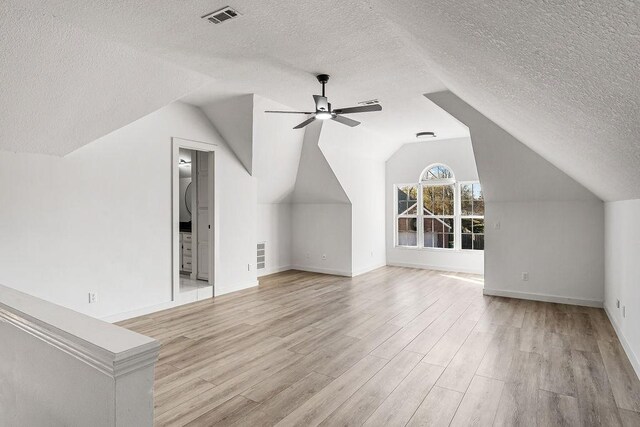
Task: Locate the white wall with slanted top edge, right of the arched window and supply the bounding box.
[427,92,604,306]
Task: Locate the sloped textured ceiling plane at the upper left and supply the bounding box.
[0,1,207,155]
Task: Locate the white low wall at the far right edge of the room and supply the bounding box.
[605,200,640,376]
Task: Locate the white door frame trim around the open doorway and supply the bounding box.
[171,137,220,301]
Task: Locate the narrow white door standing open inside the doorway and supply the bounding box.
[196,151,211,280]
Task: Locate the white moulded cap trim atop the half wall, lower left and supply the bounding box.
[0,285,160,378]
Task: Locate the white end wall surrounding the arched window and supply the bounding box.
[384,138,484,274]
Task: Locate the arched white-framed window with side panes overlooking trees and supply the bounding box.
[394,164,484,250]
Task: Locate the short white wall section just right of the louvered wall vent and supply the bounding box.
[257,203,292,276]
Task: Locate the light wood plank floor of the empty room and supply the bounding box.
[120,267,640,426]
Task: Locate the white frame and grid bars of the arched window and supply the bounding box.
[393,163,486,252]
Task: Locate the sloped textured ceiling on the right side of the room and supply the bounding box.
[373,0,640,200]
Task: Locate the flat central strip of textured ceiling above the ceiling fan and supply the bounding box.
[6,0,467,154]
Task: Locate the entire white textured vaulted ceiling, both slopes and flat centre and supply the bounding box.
[0,0,640,200]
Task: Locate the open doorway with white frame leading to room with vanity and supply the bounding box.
[172,138,216,303]
